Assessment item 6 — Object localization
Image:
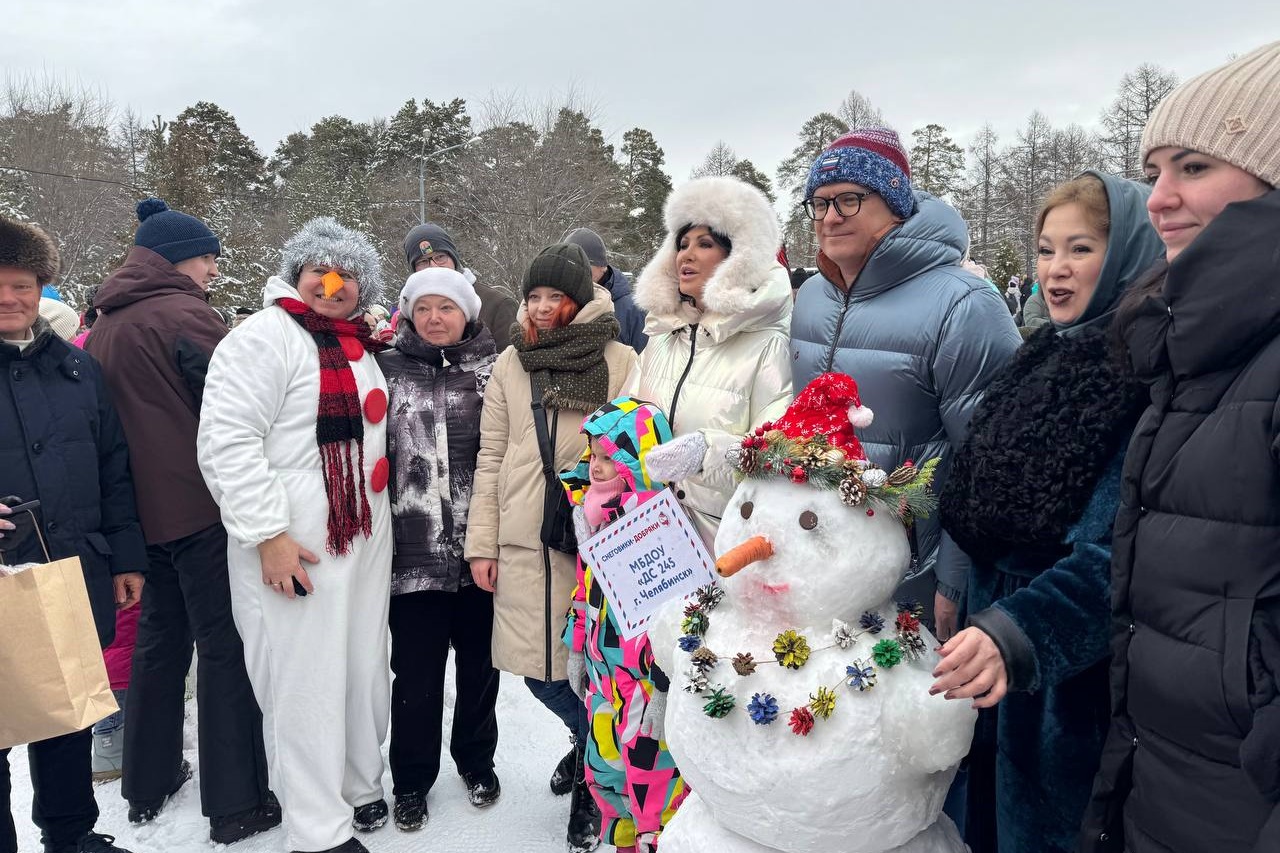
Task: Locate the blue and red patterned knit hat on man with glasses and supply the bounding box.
[804,127,915,219]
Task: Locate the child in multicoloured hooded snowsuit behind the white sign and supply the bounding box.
[561,397,689,853]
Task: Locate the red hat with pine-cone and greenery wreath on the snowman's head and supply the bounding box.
[730,373,938,524]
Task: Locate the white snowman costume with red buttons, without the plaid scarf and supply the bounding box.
[198,230,393,850]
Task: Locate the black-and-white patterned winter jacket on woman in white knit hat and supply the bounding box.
[378,318,498,596]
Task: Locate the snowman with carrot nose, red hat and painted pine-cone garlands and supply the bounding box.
[649,374,977,853]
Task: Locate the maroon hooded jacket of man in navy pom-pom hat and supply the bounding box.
[84,246,227,544]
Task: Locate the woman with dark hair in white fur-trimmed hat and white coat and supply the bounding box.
[626,177,792,548]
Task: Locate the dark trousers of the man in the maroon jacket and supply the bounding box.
[122,524,268,817]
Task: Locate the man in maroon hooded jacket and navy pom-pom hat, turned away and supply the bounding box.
[86,199,280,844]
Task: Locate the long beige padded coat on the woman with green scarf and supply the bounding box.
[466,284,636,681]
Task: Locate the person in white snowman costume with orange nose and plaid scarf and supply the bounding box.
[198,218,393,853]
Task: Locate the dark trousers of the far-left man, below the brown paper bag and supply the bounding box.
[0,729,97,853]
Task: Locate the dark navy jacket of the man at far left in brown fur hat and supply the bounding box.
[0,319,147,647]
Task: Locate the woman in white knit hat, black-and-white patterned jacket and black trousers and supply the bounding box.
[378,266,500,831]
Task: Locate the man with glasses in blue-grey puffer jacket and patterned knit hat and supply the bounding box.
[791,128,1021,642]
